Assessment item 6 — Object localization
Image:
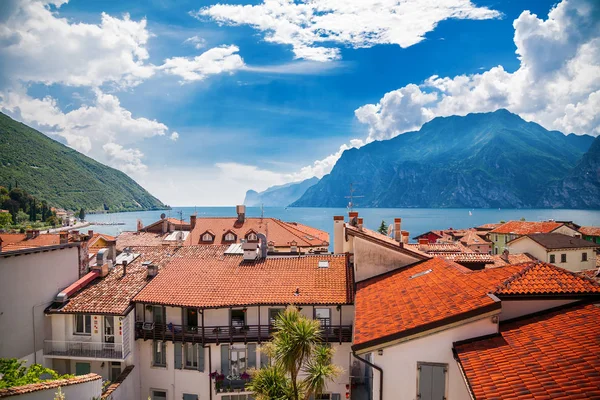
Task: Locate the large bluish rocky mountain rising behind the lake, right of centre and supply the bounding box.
[292,110,600,208]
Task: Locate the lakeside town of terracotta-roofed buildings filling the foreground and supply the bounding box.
[0,206,600,400]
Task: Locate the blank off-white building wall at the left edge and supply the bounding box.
[0,244,79,366]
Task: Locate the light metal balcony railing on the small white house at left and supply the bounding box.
[44,340,127,360]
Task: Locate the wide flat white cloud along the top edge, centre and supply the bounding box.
[197,0,501,61]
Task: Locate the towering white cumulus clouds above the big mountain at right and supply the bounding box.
[355,0,600,141]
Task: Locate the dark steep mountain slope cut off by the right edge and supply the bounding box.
[539,136,600,208]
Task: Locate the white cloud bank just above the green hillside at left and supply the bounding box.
[0,88,173,173]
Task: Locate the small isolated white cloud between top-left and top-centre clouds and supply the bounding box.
[159,46,244,83]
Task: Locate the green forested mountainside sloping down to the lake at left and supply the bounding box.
[0,113,166,211]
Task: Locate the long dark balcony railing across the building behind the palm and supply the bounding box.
[135,322,352,344]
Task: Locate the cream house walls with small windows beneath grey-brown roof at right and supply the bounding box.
[509,238,596,272]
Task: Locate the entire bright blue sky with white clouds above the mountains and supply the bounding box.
[0,0,600,205]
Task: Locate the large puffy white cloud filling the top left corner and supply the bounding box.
[0,0,154,86]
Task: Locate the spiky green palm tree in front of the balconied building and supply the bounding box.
[246,306,342,400]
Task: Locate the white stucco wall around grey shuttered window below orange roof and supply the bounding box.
[372,317,498,400]
